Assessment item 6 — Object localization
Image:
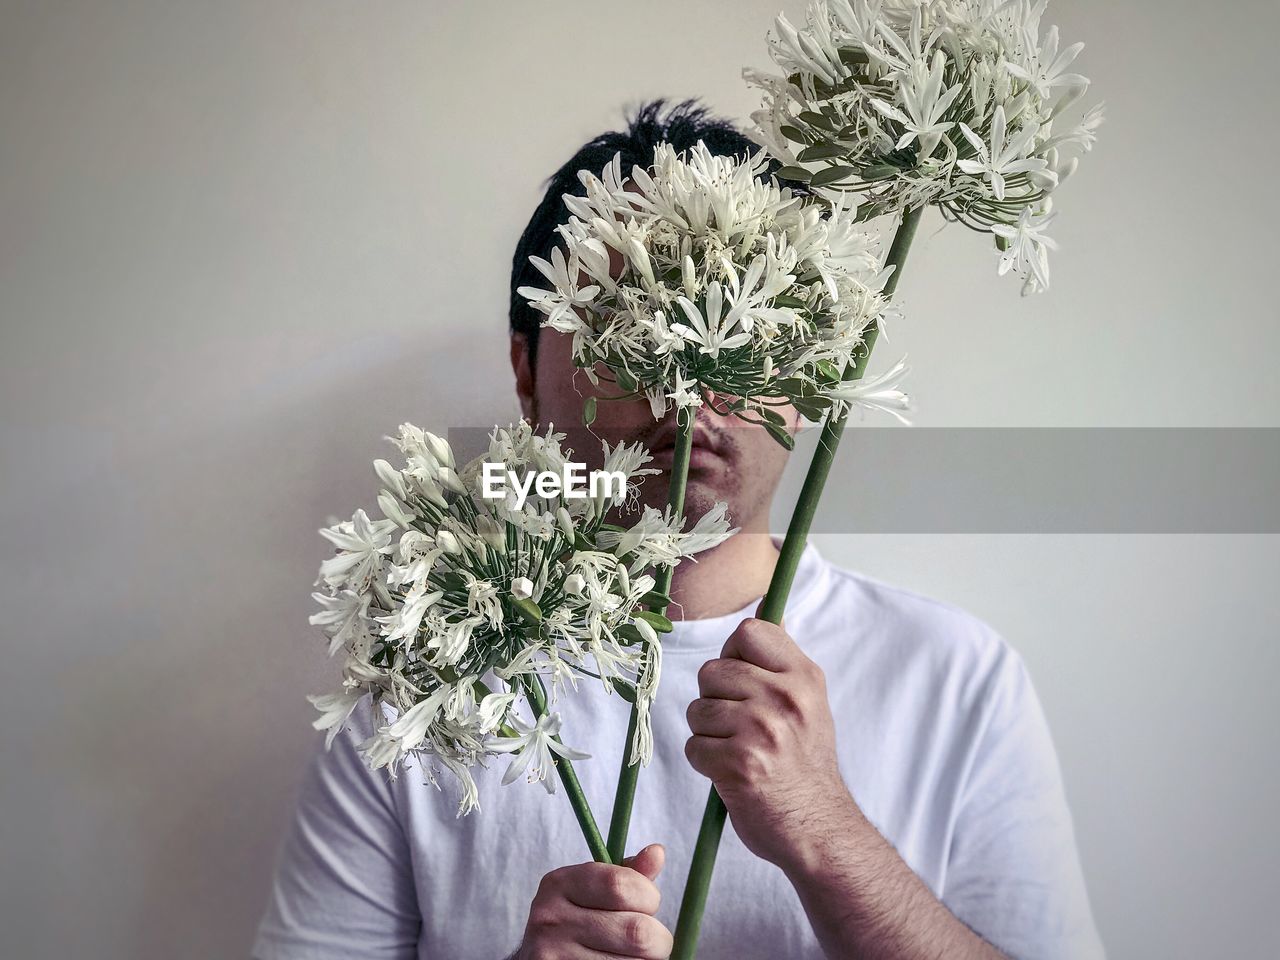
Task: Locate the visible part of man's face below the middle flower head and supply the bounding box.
[512,329,799,532]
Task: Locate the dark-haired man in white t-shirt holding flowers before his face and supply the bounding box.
[253,101,1102,960]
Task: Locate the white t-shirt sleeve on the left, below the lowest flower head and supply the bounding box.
[251,698,421,960]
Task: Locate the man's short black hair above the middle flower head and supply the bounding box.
[509,97,805,364]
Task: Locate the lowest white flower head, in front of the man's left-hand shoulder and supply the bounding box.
[310,421,732,815]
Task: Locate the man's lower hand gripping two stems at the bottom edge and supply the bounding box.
[512,844,672,960]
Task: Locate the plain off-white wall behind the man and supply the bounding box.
[0,0,1280,960]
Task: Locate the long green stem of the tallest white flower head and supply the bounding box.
[671,207,924,960]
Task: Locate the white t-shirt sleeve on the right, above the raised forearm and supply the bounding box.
[943,641,1105,960]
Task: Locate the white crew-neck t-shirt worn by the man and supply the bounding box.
[253,544,1103,960]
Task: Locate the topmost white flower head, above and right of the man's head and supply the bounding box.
[744,0,1102,293]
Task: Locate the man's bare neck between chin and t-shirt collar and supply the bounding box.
[667,525,778,620]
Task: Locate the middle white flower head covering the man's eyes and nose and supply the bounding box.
[518,142,906,443]
